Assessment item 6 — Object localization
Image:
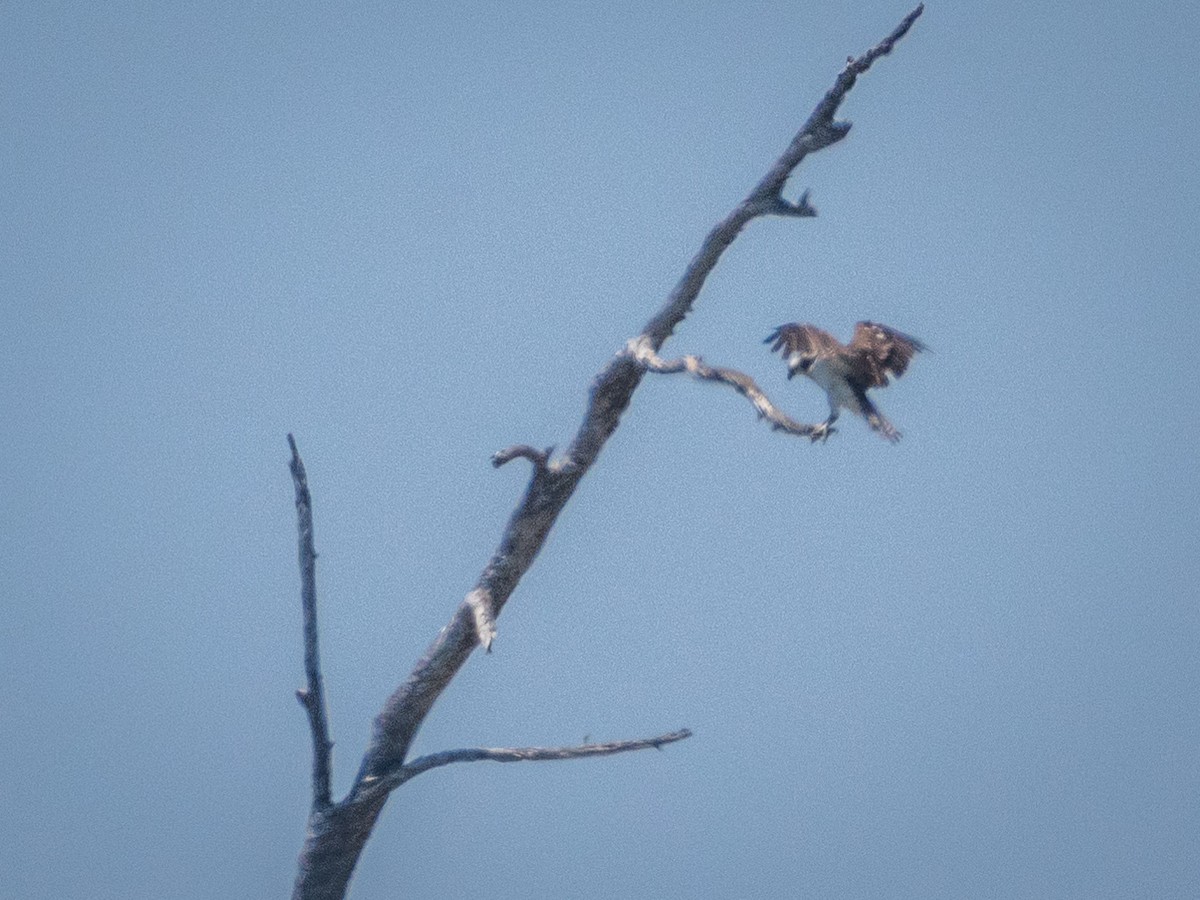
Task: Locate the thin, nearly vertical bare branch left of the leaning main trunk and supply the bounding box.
[288,434,334,811]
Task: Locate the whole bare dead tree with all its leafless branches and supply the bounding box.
[288,6,924,900]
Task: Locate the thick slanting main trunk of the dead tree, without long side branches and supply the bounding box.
[294,6,923,898]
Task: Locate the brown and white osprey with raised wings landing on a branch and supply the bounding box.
[763,322,926,443]
